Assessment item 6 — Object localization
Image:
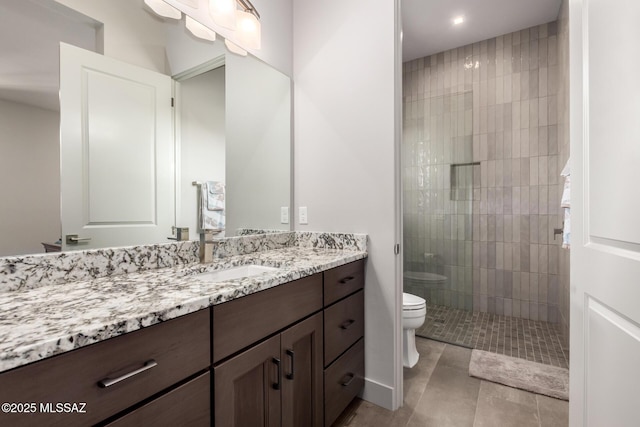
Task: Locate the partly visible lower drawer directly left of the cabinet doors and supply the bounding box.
[107,372,211,427]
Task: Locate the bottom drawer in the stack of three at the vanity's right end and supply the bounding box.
[324,339,364,426]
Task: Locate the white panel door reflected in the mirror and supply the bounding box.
[60,43,175,249]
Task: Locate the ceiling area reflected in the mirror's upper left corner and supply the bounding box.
[0,0,99,110]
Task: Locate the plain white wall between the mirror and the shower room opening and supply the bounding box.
[293,0,402,408]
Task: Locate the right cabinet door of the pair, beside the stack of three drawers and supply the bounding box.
[281,313,324,427]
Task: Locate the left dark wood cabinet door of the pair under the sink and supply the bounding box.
[214,335,282,427]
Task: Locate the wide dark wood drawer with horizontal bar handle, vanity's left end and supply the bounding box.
[0,310,211,426]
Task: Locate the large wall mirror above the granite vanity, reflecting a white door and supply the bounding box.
[0,0,291,256]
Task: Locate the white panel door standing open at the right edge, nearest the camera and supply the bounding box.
[570,0,640,427]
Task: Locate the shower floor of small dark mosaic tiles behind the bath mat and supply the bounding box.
[416,305,569,368]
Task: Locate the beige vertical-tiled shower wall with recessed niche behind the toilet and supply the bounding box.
[403,15,568,352]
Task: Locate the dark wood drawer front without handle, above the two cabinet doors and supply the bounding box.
[213,274,322,363]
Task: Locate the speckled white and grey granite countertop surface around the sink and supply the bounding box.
[0,247,367,372]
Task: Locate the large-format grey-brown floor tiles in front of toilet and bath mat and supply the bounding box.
[334,338,569,427]
